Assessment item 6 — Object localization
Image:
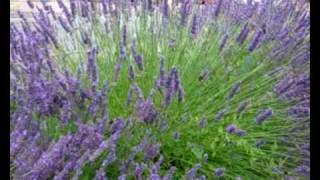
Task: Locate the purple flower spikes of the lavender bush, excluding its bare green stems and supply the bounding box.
[10,0,310,180]
